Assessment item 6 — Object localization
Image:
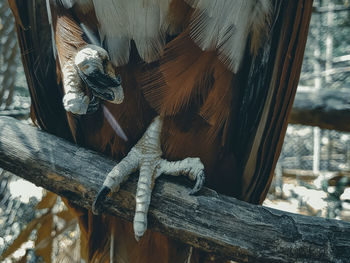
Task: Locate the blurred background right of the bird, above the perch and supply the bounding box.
[264,0,350,221]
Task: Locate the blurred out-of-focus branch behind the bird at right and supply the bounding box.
[289,89,350,132]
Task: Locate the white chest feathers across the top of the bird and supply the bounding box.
[72,0,271,72]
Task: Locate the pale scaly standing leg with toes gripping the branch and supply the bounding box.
[92,116,204,240]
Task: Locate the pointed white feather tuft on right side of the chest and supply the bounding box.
[185,0,271,72]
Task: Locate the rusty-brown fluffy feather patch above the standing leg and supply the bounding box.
[139,31,237,148]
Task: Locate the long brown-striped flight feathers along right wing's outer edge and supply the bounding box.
[240,0,312,206]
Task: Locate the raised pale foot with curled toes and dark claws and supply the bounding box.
[62,45,124,115]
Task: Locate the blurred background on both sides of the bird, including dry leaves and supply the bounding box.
[0,0,350,262]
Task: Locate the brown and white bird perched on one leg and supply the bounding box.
[9,0,312,263]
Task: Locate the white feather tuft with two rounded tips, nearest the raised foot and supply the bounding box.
[93,0,171,65]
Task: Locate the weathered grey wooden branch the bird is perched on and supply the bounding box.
[0,117,350,262]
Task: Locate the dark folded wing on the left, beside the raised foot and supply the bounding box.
[9,0,72,139]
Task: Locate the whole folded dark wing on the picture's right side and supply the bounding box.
[239,0,312,203]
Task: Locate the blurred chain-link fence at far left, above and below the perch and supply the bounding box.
[0,1,34,260]
